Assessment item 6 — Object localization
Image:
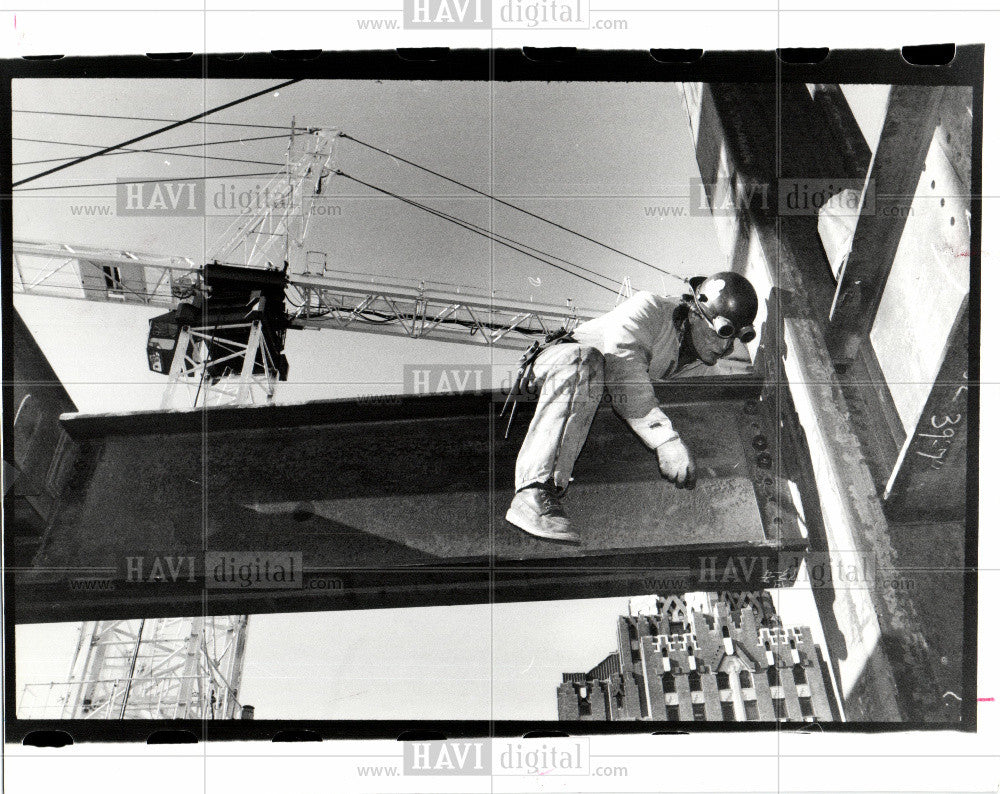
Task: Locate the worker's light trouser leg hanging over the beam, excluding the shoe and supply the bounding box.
[514,344,604,490]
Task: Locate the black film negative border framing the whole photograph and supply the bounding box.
[0,44,985,746]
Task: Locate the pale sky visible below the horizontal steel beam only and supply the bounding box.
[15,581,825,720]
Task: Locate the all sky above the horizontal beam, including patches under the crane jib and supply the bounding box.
[13,80,723,412]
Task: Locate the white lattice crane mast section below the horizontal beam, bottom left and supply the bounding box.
[17,615,247,720]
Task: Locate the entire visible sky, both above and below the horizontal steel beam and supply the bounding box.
[13,80,836,719]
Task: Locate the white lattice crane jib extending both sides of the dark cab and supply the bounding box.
[14,241,601,350]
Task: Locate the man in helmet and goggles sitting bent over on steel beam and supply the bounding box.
[507,272,757,543]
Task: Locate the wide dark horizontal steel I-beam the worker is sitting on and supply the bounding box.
[12,366,806,622]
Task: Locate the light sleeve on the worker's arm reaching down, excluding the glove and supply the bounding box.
[603,292,677,449]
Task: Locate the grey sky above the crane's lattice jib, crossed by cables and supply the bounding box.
[14,80,722,298]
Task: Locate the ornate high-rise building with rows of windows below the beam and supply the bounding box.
[557,592,839,722]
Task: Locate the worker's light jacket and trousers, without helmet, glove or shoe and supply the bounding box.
[514,292,682,490]
